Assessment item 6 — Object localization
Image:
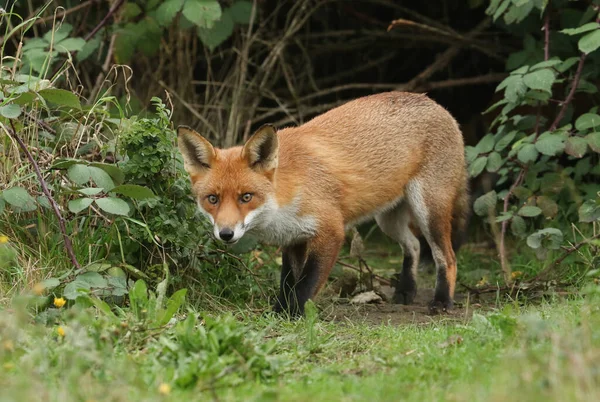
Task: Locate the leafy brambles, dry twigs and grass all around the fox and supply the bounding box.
[0,0,600,400]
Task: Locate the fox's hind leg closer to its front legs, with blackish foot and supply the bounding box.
[375,202,420,304]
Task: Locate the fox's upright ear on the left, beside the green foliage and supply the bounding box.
[177,126,215,174]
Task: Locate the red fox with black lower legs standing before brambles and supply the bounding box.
[177,92,469,315]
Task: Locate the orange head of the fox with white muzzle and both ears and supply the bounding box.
[177,125,279,243]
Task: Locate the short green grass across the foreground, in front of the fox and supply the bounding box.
[0,290,600,401]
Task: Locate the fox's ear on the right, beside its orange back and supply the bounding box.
[242,124,279,172]
